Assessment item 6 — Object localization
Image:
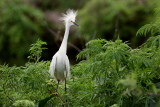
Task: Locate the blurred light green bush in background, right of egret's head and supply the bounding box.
[79,0,156,47]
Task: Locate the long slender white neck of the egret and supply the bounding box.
[59,23,70,54]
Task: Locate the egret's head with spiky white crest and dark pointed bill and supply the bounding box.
[60,9,80,27]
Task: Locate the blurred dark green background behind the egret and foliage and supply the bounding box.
[0,0,160,66]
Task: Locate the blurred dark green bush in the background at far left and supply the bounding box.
[0,0,44,65]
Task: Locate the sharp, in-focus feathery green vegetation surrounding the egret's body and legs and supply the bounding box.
[0,9,160,107]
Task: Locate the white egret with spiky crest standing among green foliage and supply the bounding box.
[49,9,79,97]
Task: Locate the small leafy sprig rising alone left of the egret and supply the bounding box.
[28,39,47,62]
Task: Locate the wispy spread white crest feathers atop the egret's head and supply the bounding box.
[60,9,77,22]
